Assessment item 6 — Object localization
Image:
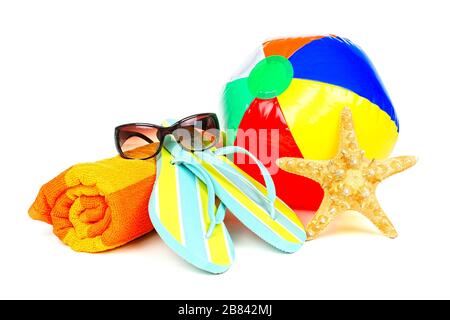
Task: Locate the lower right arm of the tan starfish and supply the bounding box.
[361,195,397,239]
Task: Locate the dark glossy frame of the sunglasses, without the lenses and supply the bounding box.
[114,113,220,160]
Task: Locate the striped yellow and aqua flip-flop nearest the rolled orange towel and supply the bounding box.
[149,144,234,274]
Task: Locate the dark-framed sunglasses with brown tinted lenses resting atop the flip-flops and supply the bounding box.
[114,113,220,160]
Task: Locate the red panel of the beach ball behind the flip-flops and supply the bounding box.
[234,98,323,210]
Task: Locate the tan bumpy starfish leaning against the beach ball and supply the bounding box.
[277,107,417,240]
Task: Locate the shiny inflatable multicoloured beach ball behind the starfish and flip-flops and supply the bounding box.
[222,36,399,210]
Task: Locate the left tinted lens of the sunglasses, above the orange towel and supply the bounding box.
[117,125,160,159]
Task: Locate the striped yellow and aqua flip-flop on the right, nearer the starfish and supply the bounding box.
[164,122,306,253]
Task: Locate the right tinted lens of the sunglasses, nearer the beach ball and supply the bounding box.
[173,115,220,151]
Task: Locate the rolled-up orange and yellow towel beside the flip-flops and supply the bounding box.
[29,157,156,252]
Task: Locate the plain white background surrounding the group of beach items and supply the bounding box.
[0,0,450,299]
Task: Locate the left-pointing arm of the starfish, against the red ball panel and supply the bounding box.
[277,157,329,183]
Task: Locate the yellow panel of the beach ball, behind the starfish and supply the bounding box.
[278,79,398,160]
